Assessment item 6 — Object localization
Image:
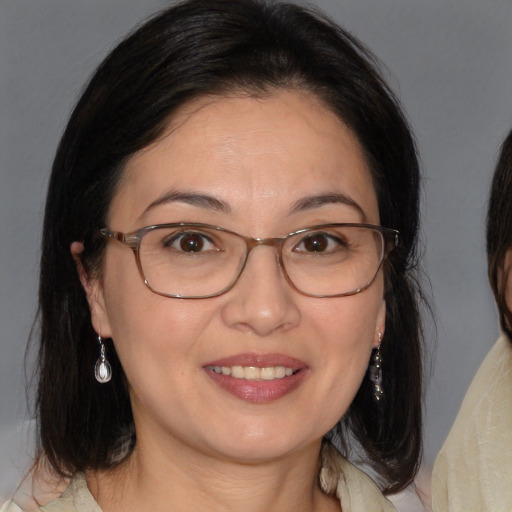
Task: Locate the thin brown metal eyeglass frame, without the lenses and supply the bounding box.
[100,222,399,299]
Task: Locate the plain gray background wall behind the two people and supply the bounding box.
[0,0,512,496]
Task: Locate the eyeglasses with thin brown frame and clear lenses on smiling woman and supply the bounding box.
[100,223,398,299]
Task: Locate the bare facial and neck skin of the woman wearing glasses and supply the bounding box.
[76,91,385,512]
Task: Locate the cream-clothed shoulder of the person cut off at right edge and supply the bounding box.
[432,336,512,511]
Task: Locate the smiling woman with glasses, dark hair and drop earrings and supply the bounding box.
[1,0,421,512]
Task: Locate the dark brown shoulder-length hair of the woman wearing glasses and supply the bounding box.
[37,0,422,491]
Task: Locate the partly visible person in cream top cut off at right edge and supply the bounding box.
[432,127,512,512]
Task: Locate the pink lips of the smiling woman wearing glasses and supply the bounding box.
[203,353,309,404]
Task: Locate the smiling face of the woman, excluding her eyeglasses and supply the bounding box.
[87,91,385,461]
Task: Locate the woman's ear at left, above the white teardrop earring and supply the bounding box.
[70,242,112,338]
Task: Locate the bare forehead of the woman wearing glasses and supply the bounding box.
[111,91,378,227]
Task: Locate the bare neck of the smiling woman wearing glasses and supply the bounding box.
[88,432,340,512]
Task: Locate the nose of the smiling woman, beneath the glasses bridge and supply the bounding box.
[222,246,301,336]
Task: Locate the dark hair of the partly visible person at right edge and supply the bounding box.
[487,131,512,340]
